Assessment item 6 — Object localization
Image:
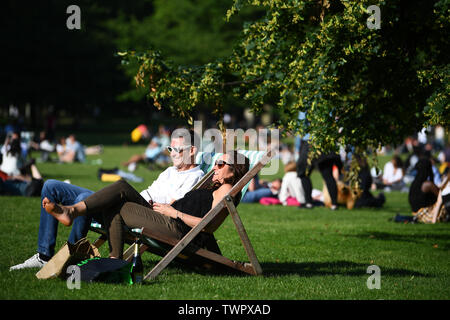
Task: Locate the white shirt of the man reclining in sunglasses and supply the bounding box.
[141,166,204,203]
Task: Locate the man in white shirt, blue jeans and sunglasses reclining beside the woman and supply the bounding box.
[10,130,204,270]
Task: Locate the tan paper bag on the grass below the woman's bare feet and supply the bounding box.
[36,238,100,279]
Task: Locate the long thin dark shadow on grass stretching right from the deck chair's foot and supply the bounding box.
[261,261,430,277]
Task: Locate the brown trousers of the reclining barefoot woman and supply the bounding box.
[84,180,184,259]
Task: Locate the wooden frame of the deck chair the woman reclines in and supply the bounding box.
[90,150,275,280]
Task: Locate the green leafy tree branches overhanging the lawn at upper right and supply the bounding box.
[121,0,450,155]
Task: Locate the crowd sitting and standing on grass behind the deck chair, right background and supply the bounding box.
[243,131,450,221]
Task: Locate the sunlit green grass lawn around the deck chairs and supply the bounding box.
[0,146,450,300]
